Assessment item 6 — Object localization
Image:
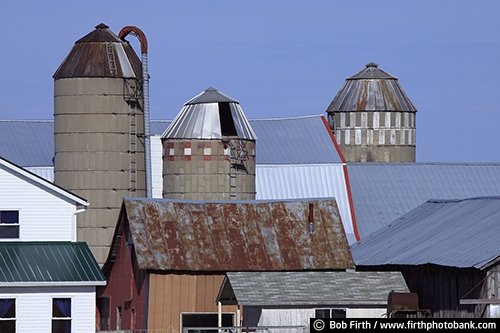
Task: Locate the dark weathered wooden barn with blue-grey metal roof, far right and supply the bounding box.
[351,197,500,318]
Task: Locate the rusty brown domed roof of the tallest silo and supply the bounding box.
[53,23,142,80]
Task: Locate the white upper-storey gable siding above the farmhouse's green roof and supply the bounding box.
[0,168,77,241]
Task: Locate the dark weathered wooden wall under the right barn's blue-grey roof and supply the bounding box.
[401,265,486,318]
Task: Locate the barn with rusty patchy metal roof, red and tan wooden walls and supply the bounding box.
[98,198,358,331]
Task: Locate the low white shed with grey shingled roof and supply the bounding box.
[217,270,409,332]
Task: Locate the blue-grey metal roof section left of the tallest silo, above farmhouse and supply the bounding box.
[0,120,54,167]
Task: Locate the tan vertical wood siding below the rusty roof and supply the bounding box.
[148,273,236,331]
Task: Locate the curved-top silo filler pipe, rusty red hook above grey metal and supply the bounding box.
[118,26,153,198]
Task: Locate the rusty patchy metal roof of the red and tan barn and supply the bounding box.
[115,198,354,271]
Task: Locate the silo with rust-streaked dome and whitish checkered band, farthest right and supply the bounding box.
[326,62,417,162]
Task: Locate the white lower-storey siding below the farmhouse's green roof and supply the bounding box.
[0,287,95,333]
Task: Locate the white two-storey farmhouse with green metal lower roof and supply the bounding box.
[0,158,106,333]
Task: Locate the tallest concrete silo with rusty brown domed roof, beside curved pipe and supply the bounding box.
[53,24,146,264]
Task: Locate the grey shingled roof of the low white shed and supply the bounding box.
[217,270,409,307]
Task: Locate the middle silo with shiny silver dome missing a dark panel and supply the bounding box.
[162,87,257,200]
